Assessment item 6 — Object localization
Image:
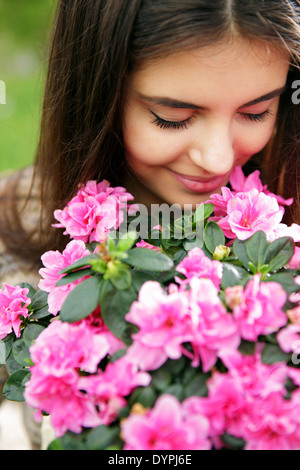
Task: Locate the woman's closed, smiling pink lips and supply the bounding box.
[169,170,229,194]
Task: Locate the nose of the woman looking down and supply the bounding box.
[188,119,234,175]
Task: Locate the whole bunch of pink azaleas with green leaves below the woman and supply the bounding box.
[0,168,300,450]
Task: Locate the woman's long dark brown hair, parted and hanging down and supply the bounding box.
[0,0,300,261]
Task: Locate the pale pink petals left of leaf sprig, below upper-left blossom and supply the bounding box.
[39,240,91,315]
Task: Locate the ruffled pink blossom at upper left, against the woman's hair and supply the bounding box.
[54,180,133,242]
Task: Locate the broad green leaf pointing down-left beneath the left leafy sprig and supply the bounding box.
[60,276,102,323]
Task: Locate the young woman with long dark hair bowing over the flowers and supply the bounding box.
[1,0,300,274]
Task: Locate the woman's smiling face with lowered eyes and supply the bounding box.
[123,40,289,207]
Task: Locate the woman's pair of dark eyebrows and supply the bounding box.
[138,86,286,110]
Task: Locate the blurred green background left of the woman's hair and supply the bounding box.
[0,0,57,171]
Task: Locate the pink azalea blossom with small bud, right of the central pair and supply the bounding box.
[225,274,287,341]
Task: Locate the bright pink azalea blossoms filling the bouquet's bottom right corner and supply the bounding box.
[185,347,300,450]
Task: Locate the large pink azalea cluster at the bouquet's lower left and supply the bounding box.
[25,319,150,436]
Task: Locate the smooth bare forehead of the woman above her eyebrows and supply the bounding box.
[129,39,289,106]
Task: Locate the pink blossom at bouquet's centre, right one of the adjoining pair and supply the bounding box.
[189,277,240,372]
